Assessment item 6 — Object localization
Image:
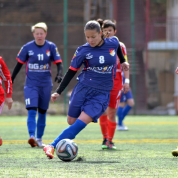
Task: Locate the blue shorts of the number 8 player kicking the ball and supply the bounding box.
[68,82,110,122]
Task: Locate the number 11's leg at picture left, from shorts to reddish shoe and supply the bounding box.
[24,86,38,147]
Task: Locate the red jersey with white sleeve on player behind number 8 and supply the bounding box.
[111,42,127,91]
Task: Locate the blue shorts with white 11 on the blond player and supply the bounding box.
[24,85,52,110]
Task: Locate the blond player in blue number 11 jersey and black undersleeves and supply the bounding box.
[12,22,63,147]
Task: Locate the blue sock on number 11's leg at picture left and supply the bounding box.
[27,110,37,137]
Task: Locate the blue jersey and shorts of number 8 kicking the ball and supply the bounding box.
[68,37,119,122]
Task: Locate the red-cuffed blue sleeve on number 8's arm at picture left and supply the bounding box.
[69,47,85,71]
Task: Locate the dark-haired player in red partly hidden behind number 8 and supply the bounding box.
[98,19,129,150]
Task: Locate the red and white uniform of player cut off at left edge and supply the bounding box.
[0,56,12,114]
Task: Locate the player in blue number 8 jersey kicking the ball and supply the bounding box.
[43,20,129,159]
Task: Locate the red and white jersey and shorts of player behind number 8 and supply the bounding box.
[109,42,127,109]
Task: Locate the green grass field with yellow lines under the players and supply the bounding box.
[0,116,178,178]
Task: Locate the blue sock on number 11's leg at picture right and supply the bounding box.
[37,112,46,138]
